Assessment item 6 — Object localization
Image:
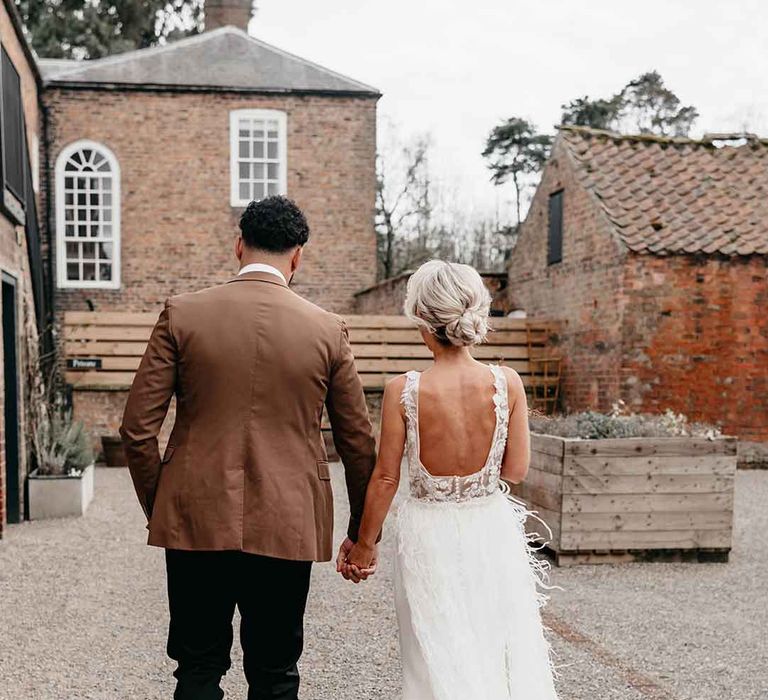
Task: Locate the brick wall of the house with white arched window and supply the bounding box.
[44,89,376,311]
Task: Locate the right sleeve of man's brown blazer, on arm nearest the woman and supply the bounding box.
[326,321,376,542]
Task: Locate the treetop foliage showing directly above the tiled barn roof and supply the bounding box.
[561,71,699,136]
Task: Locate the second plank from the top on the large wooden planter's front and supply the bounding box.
[563,455,736,476]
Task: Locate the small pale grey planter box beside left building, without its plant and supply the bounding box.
[29,464,94,520]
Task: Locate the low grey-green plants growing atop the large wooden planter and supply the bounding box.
[529,402,720,440]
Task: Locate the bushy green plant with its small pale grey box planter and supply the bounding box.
[29,401,94,520]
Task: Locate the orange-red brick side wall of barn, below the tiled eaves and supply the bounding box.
[621,254,768,441]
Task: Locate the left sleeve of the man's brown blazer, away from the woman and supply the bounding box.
[120,300,178,519]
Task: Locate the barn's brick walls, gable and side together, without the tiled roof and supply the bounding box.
[509,139,768,442]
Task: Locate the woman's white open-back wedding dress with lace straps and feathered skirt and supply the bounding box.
[395,366,557,700]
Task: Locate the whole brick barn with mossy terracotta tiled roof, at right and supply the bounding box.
[509,127,768,458]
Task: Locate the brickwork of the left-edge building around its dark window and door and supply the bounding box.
[0,5,39,537]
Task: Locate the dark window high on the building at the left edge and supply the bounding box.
[0,49,25,205]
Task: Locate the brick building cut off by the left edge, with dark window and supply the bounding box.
[0,0,47,537]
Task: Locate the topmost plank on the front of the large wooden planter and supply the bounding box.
[565,437,736,457]
